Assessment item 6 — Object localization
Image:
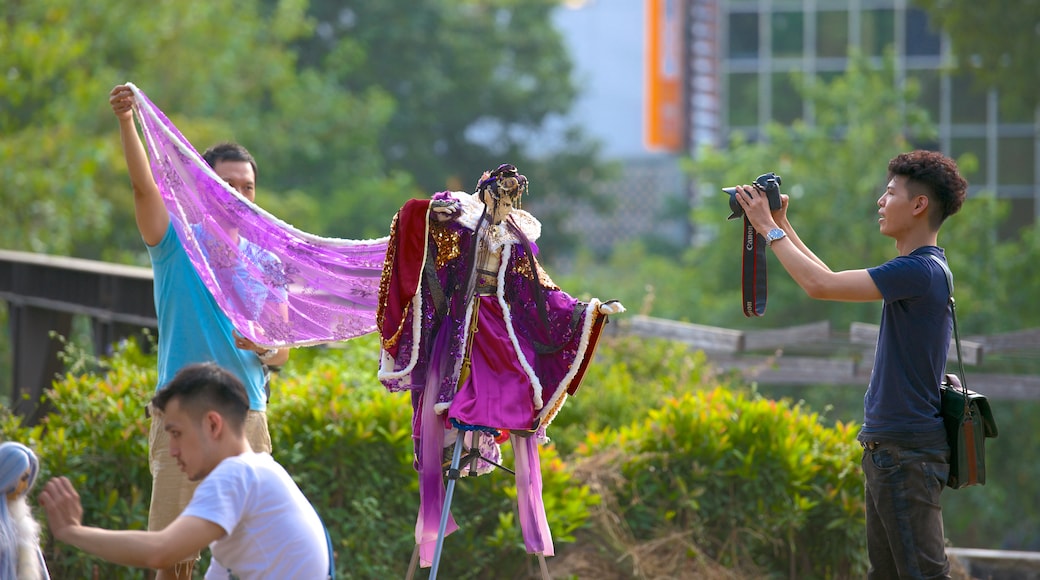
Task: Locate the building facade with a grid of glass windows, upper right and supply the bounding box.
[715,0,1040,229]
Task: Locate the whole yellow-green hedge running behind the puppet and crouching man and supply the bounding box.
[0,336,865,579]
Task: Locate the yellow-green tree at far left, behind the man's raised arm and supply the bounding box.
[0,0,397,262]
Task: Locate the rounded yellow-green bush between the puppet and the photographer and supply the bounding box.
[581,388,865,578]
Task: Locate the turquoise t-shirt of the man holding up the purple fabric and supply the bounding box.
[147,223,267,411]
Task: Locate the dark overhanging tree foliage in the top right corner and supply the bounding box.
[917,0,1040,114]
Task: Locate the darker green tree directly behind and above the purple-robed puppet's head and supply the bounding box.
[268,0,616,251]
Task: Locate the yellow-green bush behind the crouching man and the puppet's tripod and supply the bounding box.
[0,337,598,579]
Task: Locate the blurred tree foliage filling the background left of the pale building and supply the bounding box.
[0,0,604,262]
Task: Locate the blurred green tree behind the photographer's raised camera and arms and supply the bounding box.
[688,52,933,332]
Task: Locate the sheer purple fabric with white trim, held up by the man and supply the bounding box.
[130,84,388,347]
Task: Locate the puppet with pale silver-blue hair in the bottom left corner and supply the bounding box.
[0,442,50,580]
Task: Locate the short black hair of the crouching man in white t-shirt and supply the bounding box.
[152,363,250,432]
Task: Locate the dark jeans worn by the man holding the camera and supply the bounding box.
[861,443,950,580]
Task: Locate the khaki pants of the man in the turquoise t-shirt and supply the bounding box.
[148,404,271,561]
